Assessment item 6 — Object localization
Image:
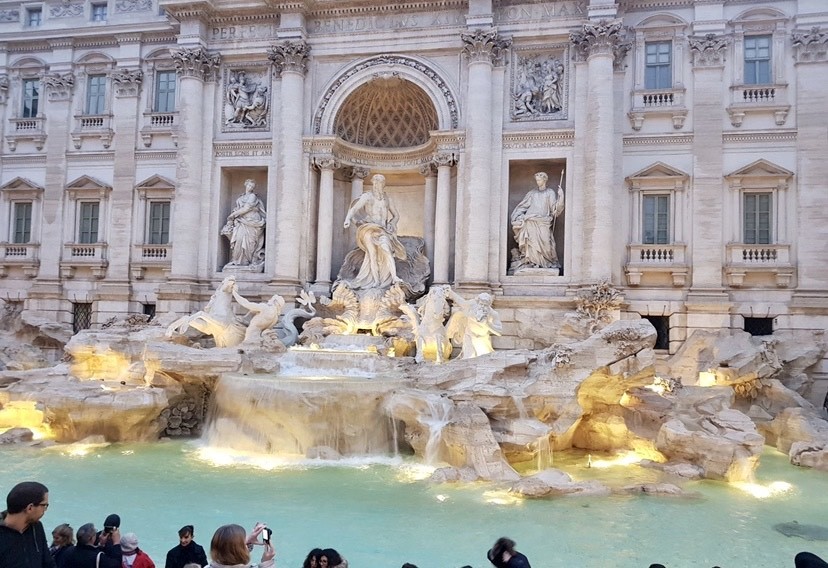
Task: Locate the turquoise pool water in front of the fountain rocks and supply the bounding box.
[0,442,828,568]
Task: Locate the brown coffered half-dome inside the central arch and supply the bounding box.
[335,75,437,148]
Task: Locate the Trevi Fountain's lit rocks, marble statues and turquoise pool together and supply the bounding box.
[0,178,828,567]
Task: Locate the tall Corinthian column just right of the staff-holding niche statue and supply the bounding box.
[570,20,628,281]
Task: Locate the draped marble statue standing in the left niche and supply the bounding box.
[221,179,266,272]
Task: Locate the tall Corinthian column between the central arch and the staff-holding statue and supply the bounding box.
[460,29,512,288]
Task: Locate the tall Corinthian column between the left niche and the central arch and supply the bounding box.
[268,40,310,286]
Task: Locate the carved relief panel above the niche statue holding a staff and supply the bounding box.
[509,46,569,121]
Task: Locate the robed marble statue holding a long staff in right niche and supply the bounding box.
[509,172,564,274]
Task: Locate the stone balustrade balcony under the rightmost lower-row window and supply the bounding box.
[725,243,795,288]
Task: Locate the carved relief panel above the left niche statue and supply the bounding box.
[221,64,272,132]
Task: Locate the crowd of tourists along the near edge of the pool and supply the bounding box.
[0,481,828,568]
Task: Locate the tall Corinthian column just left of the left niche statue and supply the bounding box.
[170,47,221,281]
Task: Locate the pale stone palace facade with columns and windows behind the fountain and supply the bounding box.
[0,0,828,378]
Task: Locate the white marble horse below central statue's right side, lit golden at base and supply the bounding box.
[400,286,451,363]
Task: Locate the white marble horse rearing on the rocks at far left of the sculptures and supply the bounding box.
[165,276,245,347]
